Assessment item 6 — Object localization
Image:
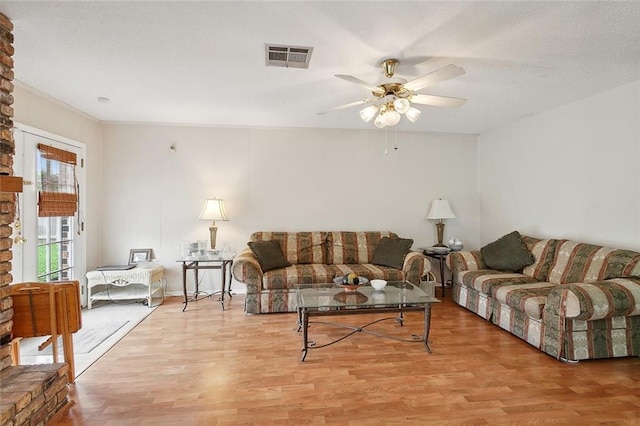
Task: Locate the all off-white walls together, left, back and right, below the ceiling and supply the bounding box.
[14,78,640,293]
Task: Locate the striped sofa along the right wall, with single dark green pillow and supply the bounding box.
[447,236,640,361]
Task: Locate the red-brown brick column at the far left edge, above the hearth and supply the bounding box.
[0,10,16,371]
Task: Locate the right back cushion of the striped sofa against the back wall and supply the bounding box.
[326,231,398,265]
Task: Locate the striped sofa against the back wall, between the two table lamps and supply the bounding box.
[232,231,430,314]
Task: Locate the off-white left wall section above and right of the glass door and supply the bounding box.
[13,82,102,272]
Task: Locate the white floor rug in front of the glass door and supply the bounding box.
[20,301,155,377]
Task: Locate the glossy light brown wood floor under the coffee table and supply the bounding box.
[57,295,640,426]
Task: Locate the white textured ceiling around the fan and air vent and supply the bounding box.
[0,1,640,133]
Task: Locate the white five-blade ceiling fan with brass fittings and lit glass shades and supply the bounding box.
[320,59,466,128]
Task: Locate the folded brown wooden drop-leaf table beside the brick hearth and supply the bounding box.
[8,281,82,383]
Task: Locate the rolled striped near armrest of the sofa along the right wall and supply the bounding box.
[543,278,640,322]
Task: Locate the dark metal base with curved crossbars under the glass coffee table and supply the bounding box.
[298,303,431,362]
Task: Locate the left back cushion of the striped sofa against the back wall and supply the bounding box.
[250,231,327,264]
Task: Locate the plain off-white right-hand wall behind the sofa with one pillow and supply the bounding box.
[478,81,640,250]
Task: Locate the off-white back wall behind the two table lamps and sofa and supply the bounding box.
[100,123,478,294]
